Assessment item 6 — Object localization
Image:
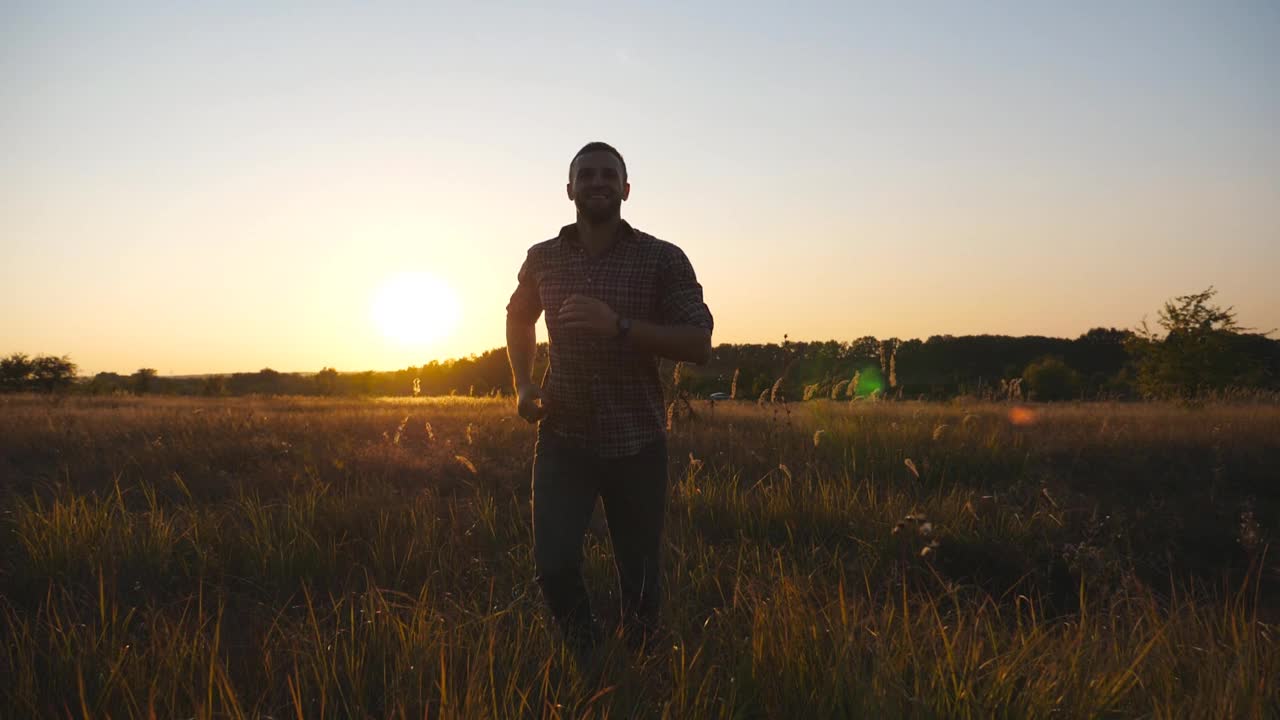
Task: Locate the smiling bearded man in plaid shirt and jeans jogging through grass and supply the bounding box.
[507,142,712,659]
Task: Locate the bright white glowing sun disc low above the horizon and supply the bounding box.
[370,273,460,347]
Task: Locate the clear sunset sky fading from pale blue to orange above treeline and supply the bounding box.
[0,1,1280,374]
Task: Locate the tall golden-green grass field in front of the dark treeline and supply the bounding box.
[0,396,1280,719]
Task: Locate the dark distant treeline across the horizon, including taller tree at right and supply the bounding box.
[0,288,1280,401]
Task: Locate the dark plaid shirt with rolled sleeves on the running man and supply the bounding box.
[507,220,712,457]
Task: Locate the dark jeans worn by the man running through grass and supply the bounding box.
[534,433,667,646]
